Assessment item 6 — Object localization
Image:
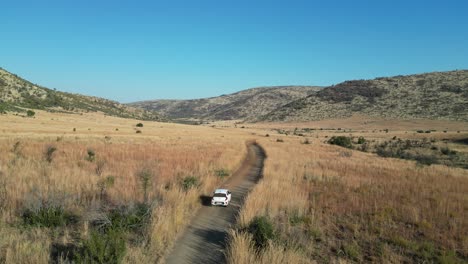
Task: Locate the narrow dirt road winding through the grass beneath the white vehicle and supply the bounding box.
[166,143,266,264]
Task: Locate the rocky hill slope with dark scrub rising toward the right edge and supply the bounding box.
[257,70,468,121]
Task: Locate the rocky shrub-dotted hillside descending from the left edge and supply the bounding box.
[0,68,160,120]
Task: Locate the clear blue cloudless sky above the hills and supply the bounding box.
[0,0,468,102]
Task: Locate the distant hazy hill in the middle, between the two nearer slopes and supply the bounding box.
[130,86,320,121]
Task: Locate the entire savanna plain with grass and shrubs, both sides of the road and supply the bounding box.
[0,111,468,263]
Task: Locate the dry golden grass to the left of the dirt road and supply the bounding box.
[0,112,246,263]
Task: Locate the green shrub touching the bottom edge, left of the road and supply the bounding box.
[75,230,126,263]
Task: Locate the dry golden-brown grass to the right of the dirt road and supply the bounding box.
[229,137,468,263]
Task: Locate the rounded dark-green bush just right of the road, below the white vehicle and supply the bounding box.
[247,216,276,249]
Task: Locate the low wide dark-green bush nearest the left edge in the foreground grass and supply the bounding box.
[21,206,77,227]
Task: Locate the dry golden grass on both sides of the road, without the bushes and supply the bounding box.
[0,111,468,263]
